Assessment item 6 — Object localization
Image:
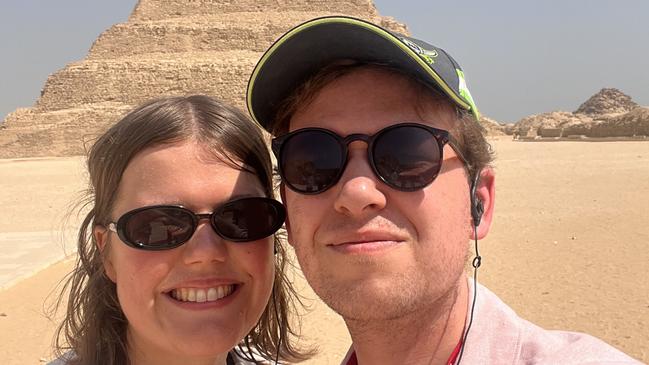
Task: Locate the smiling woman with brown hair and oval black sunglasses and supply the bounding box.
[56,96,309,365]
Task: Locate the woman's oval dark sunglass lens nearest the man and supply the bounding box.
[212,198,286,242]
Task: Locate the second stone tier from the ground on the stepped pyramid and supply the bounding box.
[36,51,259,110]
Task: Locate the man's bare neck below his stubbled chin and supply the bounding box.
[345,275,469,365]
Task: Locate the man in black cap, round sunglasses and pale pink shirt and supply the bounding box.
[248,17,637,365]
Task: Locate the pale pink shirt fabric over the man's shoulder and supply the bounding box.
[464,285,640,364]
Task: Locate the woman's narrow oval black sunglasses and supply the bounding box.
[108,197,286,251]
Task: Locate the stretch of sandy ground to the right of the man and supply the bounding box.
[481,141,649,362]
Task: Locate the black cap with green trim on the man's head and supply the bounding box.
[247,16,479,129]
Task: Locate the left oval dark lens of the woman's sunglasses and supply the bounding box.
[124,207,194,249]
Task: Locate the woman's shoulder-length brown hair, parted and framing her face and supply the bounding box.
[55,95,310,365]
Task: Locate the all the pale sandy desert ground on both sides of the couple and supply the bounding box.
[0,138,649,365]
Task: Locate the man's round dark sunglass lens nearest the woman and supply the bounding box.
[280,131,344,193]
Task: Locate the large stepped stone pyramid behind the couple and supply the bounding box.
[0,0,408,158]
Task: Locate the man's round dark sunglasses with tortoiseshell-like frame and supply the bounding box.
[272,123,464,194]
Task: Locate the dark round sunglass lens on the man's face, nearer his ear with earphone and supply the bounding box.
[372,126,441,191]
